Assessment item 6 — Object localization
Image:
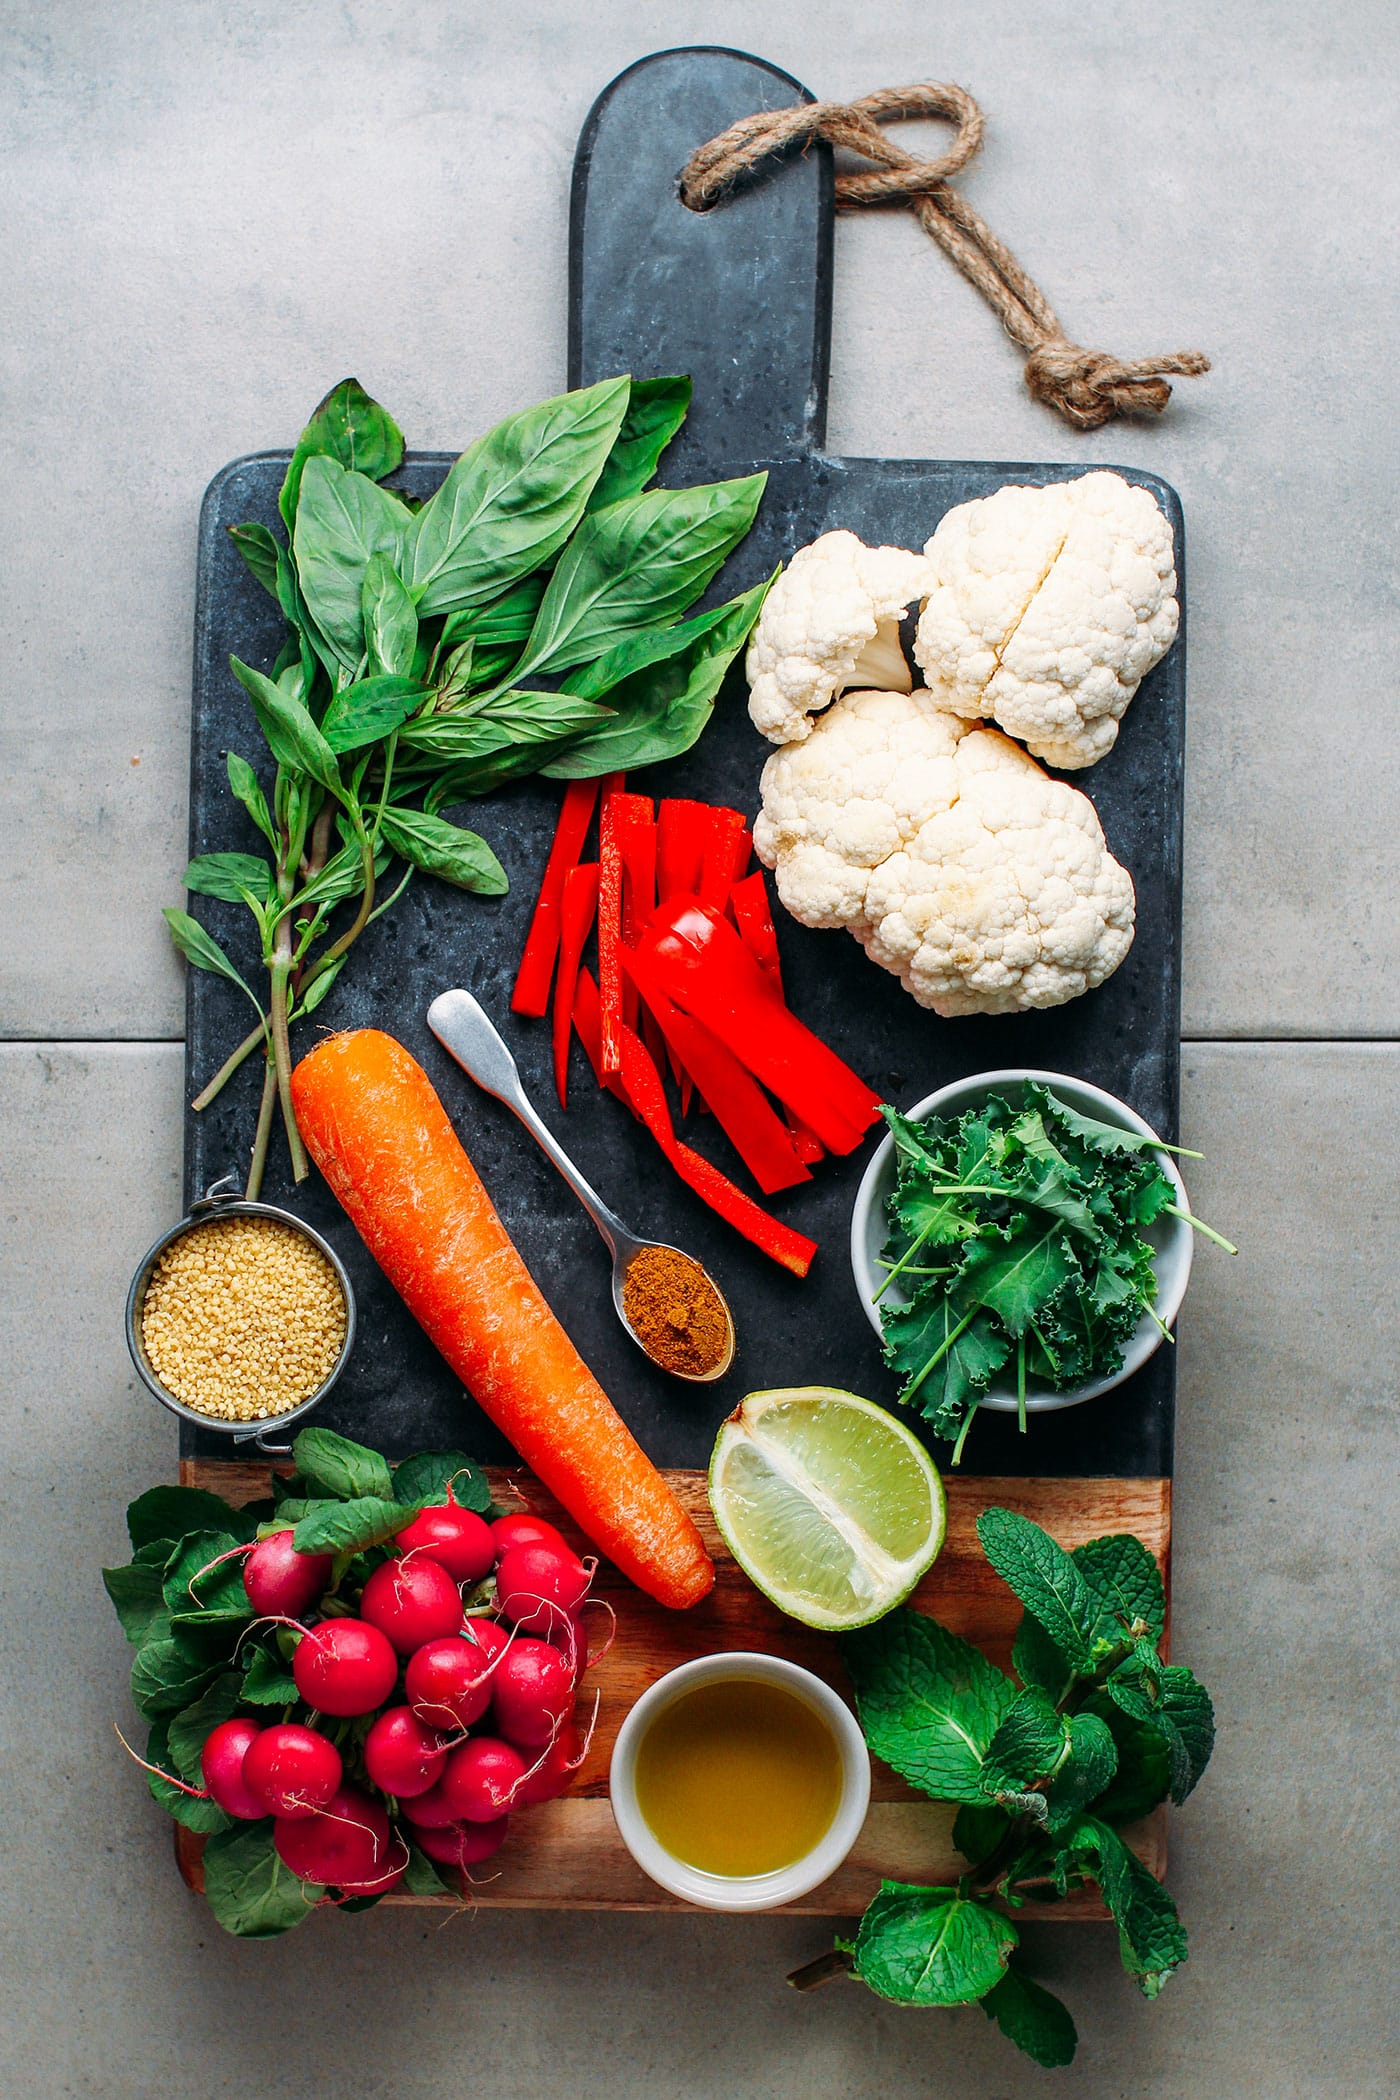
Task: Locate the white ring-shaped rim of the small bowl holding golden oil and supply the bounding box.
[609,1649,871,1911]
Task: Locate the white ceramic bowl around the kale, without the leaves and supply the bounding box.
[850,1067,1194,1415]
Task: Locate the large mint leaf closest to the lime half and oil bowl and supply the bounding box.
[842,1611,1016,1804]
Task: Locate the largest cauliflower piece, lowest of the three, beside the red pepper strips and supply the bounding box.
[754,691,1133,1014]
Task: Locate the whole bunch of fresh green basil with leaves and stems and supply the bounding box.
[166,376,768,1197]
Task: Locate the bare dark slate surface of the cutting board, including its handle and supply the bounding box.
[175,50,1186,1476]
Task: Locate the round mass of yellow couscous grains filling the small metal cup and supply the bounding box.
[141,1218,346,1422]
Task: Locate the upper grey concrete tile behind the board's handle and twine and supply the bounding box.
[0,0,1400,1040]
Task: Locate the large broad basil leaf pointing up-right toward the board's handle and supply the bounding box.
[407,378,630,620]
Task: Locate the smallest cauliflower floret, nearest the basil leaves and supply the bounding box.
[747,531,932,743]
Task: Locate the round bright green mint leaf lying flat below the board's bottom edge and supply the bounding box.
[856,1882,1016,2006]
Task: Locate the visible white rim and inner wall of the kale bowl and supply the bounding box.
[850,1065,1196,1415]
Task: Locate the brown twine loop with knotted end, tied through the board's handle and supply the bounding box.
[680,80,1211,431]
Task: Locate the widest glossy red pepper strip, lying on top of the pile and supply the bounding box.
[638,897,879,1153]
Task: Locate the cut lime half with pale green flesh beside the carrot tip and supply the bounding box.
[709,1386,947,1632]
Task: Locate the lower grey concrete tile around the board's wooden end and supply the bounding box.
[0,1044,1400,2100]
